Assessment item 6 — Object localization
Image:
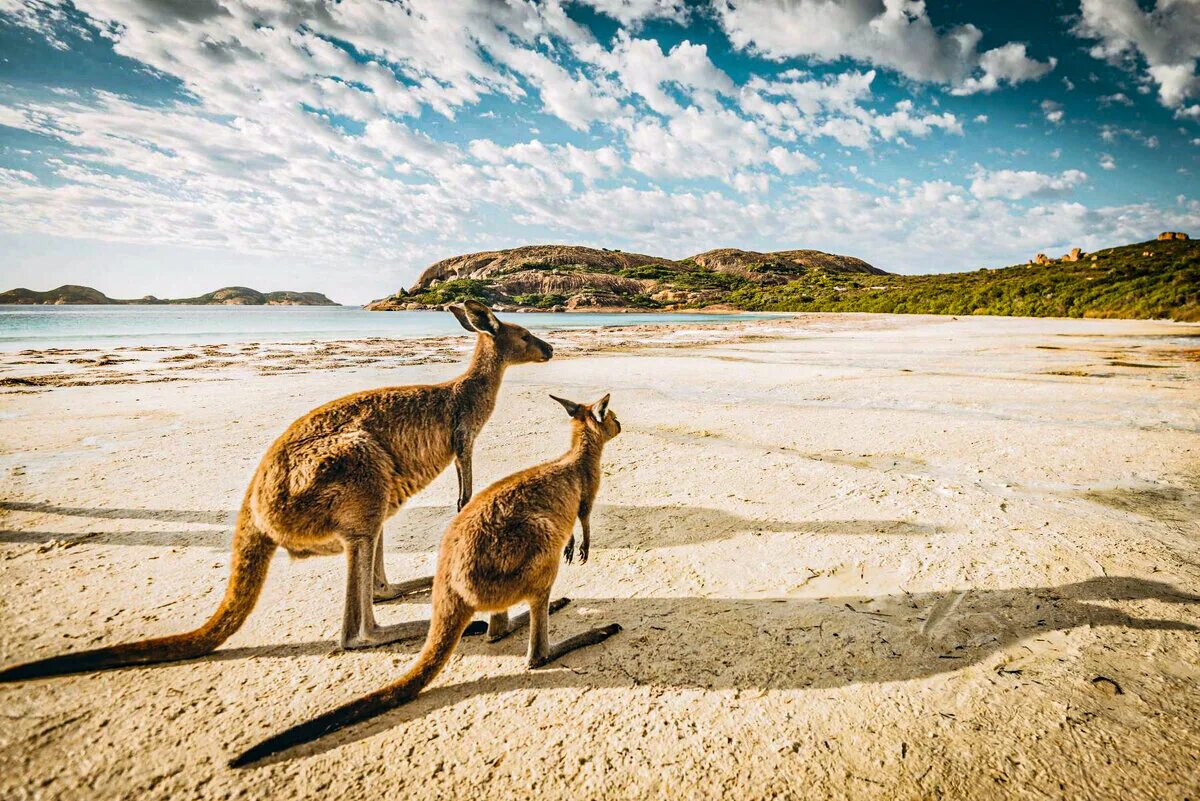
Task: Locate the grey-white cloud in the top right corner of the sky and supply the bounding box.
[1073,0,1200,108]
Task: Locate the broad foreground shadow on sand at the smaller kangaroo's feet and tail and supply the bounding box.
[241,577,1200,761]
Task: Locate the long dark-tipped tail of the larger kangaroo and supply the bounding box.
[0,507,276,682]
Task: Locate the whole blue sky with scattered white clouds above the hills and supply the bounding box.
[0,0,1200,302]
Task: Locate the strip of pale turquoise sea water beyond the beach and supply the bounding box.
[0,306,763,351]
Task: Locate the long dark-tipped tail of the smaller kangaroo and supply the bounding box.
[229,586,474,767]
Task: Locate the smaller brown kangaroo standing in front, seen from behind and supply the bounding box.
[229,395,620,767]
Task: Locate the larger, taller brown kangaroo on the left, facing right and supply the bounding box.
[0,301,553,681]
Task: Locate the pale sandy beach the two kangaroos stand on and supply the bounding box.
[0,315,1200,801]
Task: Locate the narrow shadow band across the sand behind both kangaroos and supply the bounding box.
[0,501,946,553]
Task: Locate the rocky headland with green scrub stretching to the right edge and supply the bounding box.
[366,231,1200,321]
